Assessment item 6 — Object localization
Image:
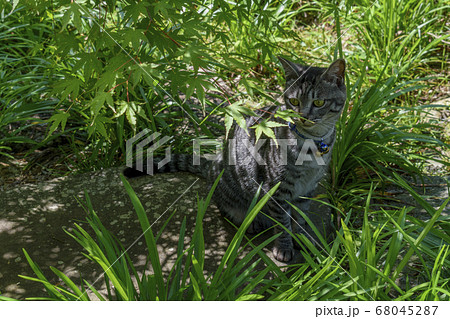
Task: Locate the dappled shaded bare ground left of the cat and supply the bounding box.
[0,168,448,299]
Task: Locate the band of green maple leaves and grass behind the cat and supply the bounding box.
[0,0,448,169]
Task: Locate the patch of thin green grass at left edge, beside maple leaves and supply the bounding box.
[0,2,56,157]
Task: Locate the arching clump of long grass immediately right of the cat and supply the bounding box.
[329,70,449,214]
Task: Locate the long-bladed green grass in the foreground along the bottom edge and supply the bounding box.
[0,176,450,301]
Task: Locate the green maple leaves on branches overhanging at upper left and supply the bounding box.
[0,0,306,147]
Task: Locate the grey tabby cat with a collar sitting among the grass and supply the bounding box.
[124,57,346,262]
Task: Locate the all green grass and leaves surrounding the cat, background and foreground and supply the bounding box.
[0,0,450,300]
